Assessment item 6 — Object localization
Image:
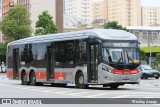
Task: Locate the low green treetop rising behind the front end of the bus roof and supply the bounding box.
[104,21,129,32]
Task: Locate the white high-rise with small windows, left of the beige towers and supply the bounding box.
[65,0,92,22]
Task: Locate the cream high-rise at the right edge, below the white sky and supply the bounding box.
[142,6,160,26]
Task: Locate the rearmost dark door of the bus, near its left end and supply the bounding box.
[13,49,19,79]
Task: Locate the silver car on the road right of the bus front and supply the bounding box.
[139,65,160,79]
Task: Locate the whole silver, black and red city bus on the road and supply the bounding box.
[6,29,140,88]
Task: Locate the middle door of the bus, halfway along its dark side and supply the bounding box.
[47,46,55,81]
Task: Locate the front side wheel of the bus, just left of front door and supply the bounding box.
[76,72,88,89]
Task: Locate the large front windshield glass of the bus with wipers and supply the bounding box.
[102,48,140,64]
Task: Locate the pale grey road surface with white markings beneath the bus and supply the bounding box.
[0,73,160,107]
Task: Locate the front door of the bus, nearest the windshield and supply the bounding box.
[88,43,98,83]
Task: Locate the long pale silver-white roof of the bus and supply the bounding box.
[8,29,137,45]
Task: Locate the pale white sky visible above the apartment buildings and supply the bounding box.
[93,0,160,6]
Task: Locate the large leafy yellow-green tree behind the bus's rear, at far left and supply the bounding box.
[0,5,32,42]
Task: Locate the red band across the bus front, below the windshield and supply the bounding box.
[113,69,139,75]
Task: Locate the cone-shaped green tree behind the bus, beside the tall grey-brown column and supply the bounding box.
[35,11,57,35]
